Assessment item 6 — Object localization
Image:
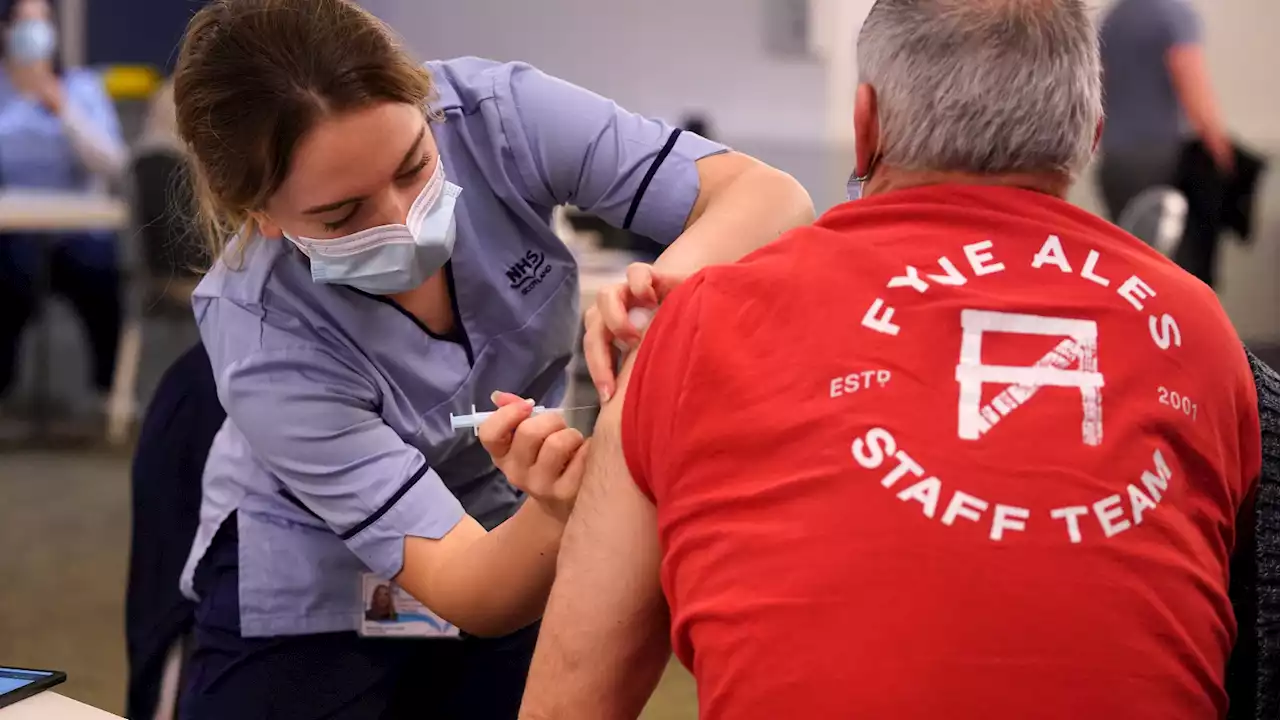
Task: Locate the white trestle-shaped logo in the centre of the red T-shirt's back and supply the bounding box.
[956,310,1106,446]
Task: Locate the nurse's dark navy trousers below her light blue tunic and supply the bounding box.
[179,514,538,720]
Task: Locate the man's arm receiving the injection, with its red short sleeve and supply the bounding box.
[522,272,701,720]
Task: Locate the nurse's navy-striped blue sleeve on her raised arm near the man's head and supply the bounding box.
[494,64,726,245]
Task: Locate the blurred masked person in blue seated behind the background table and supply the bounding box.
[0,0,127,412]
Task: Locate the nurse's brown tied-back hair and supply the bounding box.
[174,0,434,264]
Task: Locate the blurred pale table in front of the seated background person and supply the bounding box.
[0,190,132,438]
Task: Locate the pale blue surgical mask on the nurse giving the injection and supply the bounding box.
[285,161,462,295]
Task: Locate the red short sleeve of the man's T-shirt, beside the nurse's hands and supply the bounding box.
[622,274,705,502]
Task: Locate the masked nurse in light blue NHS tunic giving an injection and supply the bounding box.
[174,0,813,720]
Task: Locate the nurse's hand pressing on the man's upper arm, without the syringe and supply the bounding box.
[582,263,686,402]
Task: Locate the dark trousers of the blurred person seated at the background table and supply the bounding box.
[0,234,122,396]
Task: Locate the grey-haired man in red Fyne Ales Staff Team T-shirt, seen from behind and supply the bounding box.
[522,0,1261,720]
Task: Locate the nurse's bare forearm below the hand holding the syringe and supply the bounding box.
[396,501,564,637]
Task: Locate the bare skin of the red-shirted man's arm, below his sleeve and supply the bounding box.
[520,355,671,720]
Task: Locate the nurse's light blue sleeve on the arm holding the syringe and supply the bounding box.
[218,319,463,578]
